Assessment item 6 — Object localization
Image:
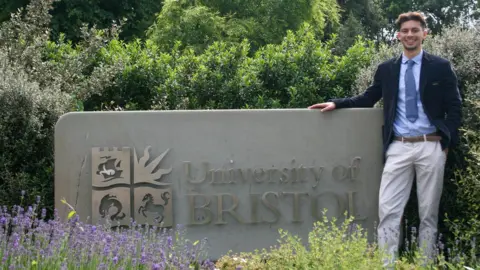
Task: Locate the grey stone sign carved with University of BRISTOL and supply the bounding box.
[55,109,383,258]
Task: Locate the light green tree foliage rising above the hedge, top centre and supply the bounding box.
[148,0,340,52]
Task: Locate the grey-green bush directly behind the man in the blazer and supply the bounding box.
[348,24,480,259]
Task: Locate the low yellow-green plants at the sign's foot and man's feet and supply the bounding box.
[215,210,480,270]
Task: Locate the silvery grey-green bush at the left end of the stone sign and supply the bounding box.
[0,0,121,210]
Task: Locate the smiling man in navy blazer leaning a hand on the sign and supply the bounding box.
[309,12,461,262]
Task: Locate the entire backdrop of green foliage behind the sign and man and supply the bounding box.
[0,0,480,264]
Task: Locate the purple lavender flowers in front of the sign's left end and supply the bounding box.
[0,197,213,269]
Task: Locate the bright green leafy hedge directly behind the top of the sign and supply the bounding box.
[89,24,374,110]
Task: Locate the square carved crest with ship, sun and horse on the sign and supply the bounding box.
[91,147,173,227]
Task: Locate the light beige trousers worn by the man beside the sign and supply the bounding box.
[377,141,446,265]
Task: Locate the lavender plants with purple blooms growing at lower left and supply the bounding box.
[0,194,214,270]
